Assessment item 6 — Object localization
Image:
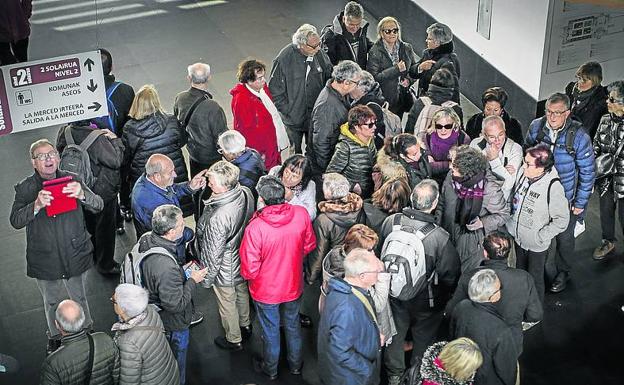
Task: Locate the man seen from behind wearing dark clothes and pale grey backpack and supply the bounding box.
[381,179,460,385]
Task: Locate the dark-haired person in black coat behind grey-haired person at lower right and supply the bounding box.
[445,232,544,352]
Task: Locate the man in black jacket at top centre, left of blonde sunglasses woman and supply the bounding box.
[322,1,373,68]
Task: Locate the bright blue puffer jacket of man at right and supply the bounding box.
[525,117,596,209]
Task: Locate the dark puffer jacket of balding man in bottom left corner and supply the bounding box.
[40,331,120,385]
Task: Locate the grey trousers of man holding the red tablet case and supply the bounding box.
[37,271,93,338]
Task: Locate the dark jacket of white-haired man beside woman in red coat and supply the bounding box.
[269,44,332,129]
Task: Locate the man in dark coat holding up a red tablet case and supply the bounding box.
[10,139,104,353]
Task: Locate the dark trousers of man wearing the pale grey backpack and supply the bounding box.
[384,298,442,376]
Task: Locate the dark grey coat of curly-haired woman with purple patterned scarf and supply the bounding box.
[436,169,509,273]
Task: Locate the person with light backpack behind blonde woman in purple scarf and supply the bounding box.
[405,68,464,141]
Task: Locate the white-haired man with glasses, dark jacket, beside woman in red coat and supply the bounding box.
[269,24,332,154]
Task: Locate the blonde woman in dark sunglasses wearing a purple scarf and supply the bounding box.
[425,107,470,185]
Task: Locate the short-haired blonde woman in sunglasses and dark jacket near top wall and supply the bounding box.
[366,16,418,117]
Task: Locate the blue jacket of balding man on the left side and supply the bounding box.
[132,174,193,236]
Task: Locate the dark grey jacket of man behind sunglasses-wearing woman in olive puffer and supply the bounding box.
[310,79,349,174]
